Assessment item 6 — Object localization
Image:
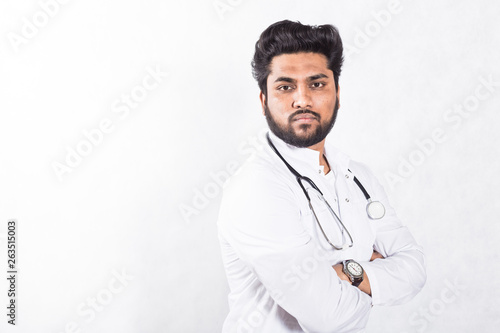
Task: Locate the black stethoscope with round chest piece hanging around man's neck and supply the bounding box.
[266,133,385,250]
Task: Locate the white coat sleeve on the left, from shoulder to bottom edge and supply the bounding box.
[219,164,371,332]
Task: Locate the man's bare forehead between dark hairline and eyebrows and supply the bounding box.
[268,52,333,79]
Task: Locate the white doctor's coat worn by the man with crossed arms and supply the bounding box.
[218,133,426,333]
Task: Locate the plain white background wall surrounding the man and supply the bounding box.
[0,0,500,333]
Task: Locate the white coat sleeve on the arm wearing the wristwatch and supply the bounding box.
[357,162,426,305]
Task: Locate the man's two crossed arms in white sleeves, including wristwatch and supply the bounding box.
[219,161,425,332]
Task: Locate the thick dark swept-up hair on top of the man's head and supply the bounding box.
[252,20,344,95]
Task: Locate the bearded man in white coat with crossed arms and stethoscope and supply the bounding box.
[218,21,426,333]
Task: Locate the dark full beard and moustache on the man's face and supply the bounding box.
[264,98,339,148]
